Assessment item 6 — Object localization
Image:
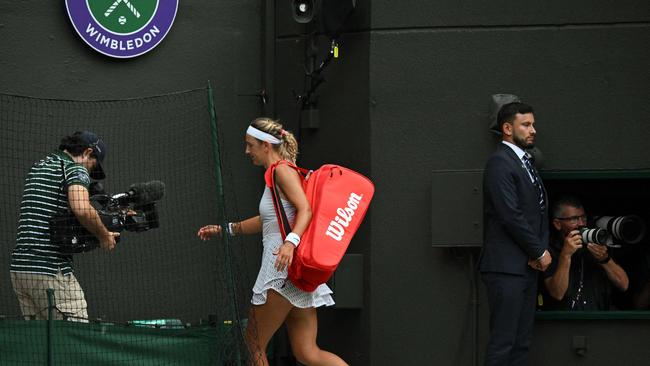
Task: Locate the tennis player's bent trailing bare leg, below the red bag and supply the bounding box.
[286,308,347,366]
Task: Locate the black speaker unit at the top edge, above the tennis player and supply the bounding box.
[291,0,356,38]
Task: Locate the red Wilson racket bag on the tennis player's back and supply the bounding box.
[265,160,375,292]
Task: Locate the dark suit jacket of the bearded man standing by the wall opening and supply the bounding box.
[479,143,549,275]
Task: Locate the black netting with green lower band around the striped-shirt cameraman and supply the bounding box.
[0,89,250,365]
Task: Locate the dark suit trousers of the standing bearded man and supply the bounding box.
[481,271,537,366]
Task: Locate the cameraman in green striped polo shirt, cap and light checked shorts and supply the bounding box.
[10,131,119,321]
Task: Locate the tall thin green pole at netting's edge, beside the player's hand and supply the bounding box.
[208,81,243,365]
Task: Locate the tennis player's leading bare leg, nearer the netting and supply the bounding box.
[246,290,293,366]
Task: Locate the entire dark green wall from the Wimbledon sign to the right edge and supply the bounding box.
[5,0,650,366]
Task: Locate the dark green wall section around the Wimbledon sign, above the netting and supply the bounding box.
[0,0,261,100]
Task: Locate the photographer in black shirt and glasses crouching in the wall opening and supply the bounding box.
[544,196,629,310]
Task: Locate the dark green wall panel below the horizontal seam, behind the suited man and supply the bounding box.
[369,22,650,365]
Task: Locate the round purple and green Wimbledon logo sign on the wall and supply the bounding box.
[65,0,178,58]
